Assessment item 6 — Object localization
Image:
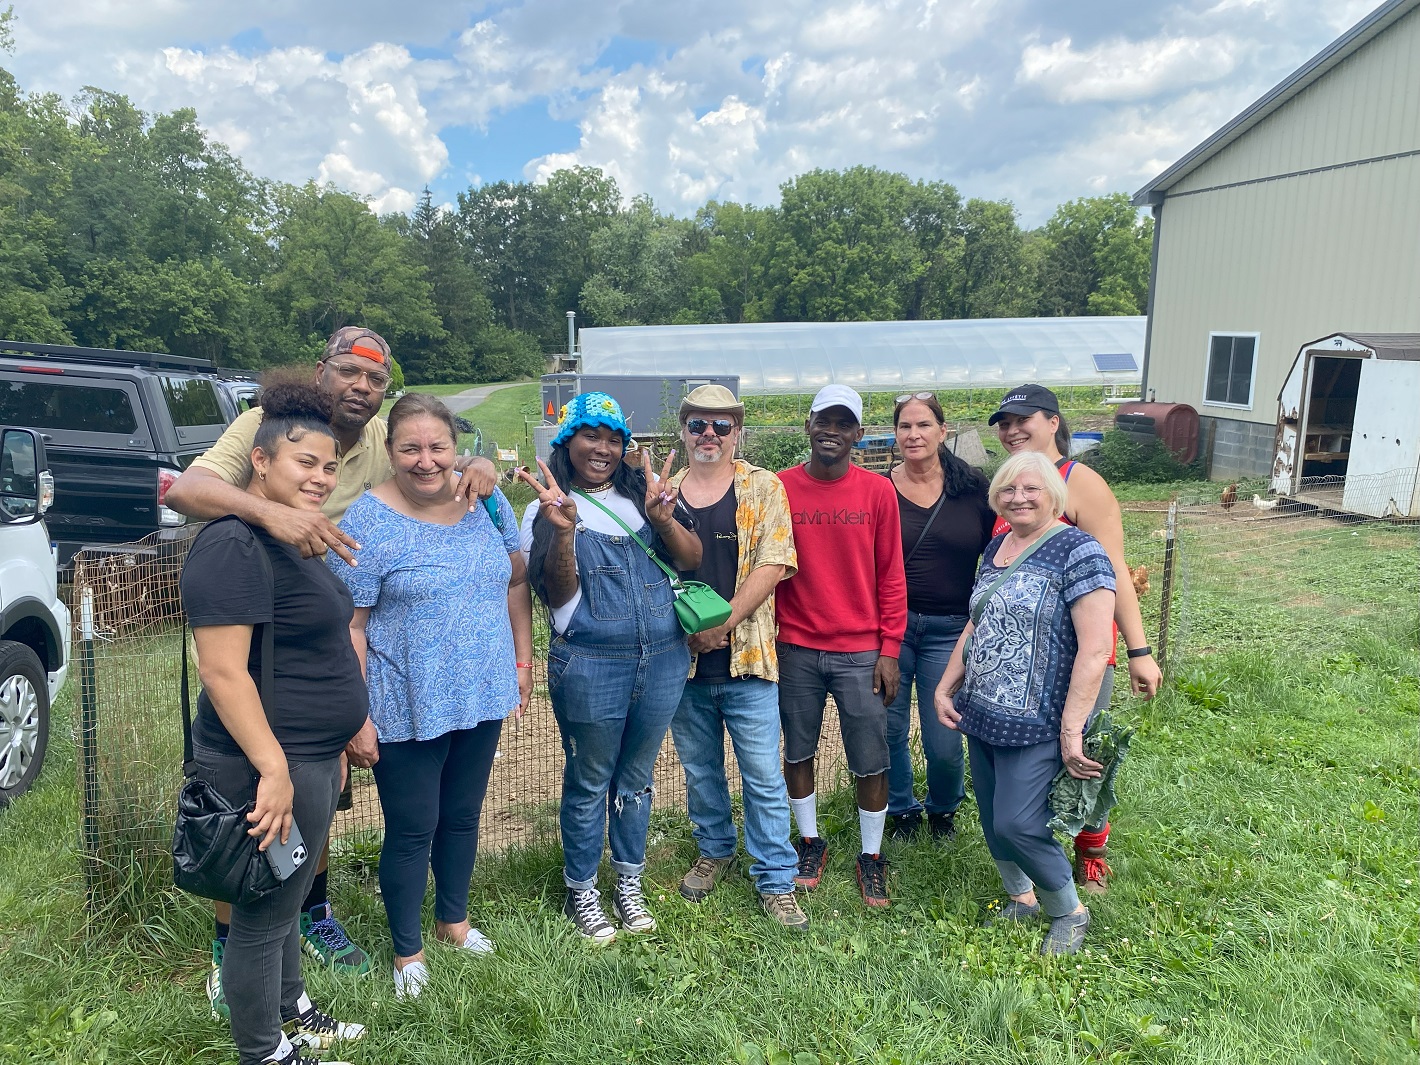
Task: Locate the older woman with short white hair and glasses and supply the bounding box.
[936,452,1115,954]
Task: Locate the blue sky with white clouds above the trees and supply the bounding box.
[6,0,1375,224]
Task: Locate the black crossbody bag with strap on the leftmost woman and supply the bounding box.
[172,531,281,905]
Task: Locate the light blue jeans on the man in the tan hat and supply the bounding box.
[670,677,798,895]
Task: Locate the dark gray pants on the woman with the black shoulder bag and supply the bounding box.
[193,747,341,1065]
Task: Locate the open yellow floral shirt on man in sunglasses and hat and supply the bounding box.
[670,459,798,682]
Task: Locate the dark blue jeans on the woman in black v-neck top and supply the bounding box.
[888,611,967,817]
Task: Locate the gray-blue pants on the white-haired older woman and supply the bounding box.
[967,736,1079,917]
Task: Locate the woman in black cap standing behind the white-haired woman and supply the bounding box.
[990,385,1163,895]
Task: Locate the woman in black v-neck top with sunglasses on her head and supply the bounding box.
[888,392,995,841]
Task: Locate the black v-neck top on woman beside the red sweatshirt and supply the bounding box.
[895,486,995,618]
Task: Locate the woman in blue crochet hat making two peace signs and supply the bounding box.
[520,392,700,943]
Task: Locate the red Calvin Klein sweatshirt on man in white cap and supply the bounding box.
[774,466,907,657]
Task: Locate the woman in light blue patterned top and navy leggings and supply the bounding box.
[331,393,533,997]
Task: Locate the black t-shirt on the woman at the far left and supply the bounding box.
[180,517,369,760]
